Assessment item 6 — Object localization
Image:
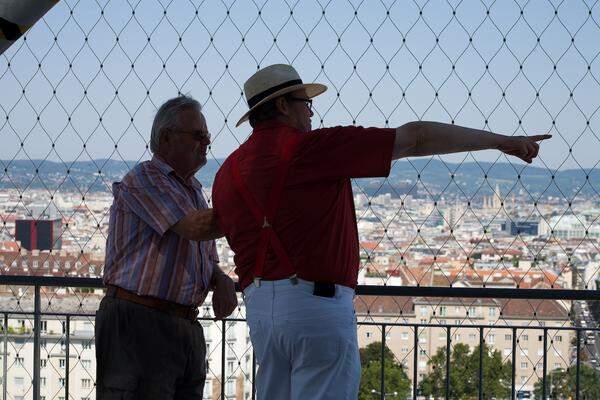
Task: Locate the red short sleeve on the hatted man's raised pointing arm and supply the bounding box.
[294,126,396,181]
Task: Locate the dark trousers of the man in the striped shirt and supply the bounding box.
[95,297,206,400]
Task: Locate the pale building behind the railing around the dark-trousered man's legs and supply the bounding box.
[0,287,253,400]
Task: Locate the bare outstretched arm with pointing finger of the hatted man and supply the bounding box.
[392,121,552,163]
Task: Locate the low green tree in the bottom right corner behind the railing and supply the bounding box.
[533,364,600,399]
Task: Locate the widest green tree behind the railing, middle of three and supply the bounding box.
[420,343,512,399]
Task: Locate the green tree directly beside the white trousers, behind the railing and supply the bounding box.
[358,342,410,400]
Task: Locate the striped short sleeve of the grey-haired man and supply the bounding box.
[119,180,195,235]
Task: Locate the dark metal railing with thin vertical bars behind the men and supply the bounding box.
[0,276,600,400]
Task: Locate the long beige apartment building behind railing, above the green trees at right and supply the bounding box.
[355,296,574,392]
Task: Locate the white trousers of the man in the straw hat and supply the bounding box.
[244,279,360,400]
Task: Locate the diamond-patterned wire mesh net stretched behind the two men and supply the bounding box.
[0,0,600,399]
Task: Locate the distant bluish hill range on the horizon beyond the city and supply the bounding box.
[0,159,600,198]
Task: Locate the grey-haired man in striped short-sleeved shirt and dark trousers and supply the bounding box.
[96,96,237,400]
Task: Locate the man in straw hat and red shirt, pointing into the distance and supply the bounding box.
[213,64,550,400]
